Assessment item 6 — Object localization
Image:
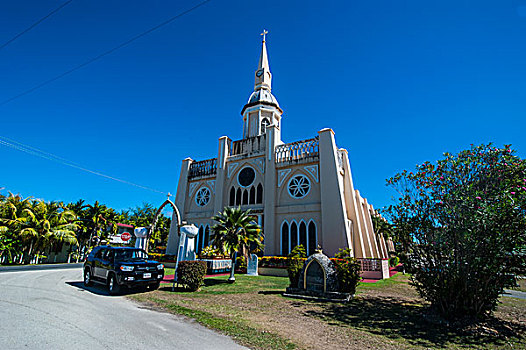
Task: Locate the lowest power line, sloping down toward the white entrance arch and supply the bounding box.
[0,136,167,195]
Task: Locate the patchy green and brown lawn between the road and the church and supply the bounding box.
[130,271,526,349]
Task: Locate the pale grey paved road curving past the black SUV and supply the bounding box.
[0,267,248,350]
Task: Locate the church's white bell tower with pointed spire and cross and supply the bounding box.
[241,30,283,141]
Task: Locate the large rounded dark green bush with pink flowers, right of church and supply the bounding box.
[388,144,526,318]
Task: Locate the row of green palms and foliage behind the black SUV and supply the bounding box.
[0,193,170,264]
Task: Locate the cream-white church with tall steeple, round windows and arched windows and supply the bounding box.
[166,32,392,259]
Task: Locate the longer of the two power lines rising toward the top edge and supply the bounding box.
[0,0,211,106]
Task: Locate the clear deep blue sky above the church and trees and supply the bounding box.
[0,0,526,209]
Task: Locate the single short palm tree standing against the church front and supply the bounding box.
[212,207,263,283]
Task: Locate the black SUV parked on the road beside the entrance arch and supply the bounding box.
[84,246,164,295]
